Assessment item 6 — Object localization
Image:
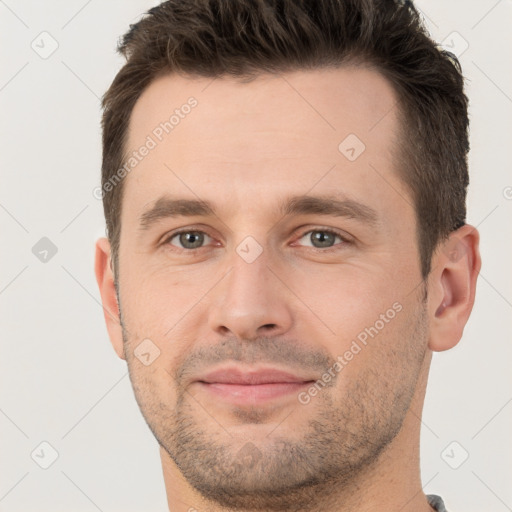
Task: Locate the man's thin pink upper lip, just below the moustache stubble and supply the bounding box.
[197,367,313,385]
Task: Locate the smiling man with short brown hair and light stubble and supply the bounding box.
[96,0,481,512]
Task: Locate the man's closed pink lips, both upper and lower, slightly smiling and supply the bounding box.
[197,368,315,405]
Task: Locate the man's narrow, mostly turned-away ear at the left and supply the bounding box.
[94,238,126,359]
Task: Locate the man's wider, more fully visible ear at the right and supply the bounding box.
[428,224,482,352]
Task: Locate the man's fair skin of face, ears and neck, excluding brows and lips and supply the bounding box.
[96,67,481,512]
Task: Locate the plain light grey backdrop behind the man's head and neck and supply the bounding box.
[0,0,512,512]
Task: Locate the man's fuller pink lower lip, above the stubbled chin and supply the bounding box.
[199,382,311,404]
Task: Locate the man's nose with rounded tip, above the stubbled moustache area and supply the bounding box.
[209,247,293,340]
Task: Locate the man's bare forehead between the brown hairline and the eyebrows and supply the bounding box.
[123,67,405,223]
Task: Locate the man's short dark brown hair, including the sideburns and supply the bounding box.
[102,0,469,278]
